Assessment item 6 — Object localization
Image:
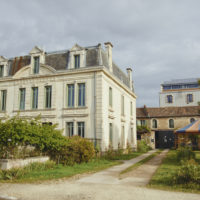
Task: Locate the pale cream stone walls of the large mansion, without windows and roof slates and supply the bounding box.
[0,43,137,151]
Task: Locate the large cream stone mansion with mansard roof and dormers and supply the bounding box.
[0,42,137,151]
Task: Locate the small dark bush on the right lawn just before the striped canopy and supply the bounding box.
[176,147,195,162]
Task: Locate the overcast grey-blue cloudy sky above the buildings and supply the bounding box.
[0,0,200,107]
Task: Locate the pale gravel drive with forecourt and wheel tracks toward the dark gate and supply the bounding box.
[0,152,200,200]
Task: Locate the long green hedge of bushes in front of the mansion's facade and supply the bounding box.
[0,115,94,165]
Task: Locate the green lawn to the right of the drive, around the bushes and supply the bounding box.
[148,150,200,193]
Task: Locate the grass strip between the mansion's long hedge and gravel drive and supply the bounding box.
[1,159,121,183]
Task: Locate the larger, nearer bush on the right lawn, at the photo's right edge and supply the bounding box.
[174,160,200,184]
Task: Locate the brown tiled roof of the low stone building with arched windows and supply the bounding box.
[136,106,200,118]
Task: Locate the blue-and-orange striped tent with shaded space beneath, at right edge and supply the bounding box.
[174,120,200,150]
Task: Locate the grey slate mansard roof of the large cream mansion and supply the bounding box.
[5,45,130,88]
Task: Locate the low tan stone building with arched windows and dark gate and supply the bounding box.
[136,106,200,148]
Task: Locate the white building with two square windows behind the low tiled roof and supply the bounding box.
[160,78,200,107]
